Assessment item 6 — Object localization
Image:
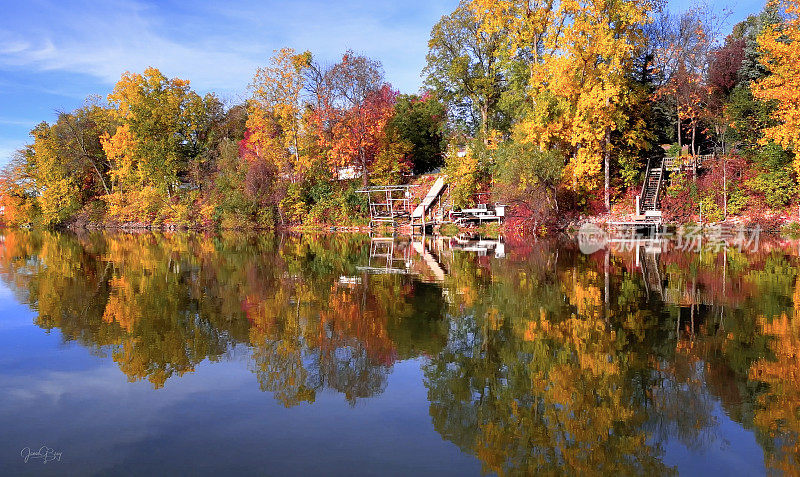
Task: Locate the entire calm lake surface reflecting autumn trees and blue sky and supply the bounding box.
[0,230,800,475]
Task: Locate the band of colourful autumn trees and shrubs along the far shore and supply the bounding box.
[0,0,800,229]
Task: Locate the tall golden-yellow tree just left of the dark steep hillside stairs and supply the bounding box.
[473,0,653,208]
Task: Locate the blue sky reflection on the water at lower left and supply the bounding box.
[0,325,480,475]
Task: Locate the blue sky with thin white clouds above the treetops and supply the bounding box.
[0,0,764,165]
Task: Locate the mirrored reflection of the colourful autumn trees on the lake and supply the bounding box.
[0,230,800,474]
